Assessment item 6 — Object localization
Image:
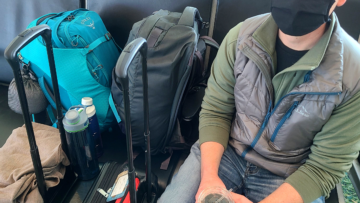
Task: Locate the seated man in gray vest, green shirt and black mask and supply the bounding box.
[159,0,360,203]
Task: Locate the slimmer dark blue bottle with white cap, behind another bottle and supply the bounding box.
[81,97,104,158]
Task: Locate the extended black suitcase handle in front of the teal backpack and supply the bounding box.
[4,25,68,202]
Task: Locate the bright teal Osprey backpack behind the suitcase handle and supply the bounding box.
[19,9,121,131]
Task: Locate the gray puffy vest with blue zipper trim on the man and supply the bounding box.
[229,14,360,177]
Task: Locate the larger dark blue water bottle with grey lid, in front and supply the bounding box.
[63,106,100,180]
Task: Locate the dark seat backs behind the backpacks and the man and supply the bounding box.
[0,0,360,83]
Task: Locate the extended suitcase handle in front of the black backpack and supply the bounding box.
[115,38,152,203]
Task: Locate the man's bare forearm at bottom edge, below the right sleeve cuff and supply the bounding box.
[260,183,304,203]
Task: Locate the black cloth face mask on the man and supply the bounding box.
[271,0,335,36]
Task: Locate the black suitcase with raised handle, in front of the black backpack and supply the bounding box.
[84,38,158,203]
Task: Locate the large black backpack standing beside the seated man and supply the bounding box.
[110,7,219,154]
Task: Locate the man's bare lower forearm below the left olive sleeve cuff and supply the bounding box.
[200,142,224,178]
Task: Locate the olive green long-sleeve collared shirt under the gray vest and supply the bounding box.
[199,20,360,202]
